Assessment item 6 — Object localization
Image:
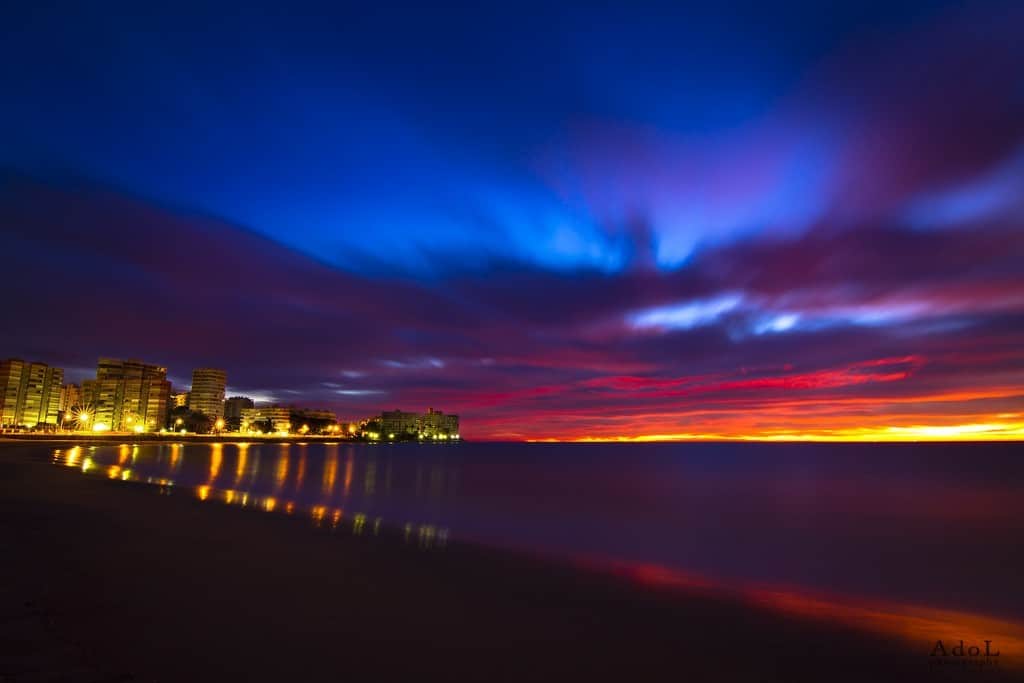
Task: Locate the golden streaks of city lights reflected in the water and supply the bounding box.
[53,443,449,549]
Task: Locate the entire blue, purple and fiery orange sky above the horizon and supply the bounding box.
[0,0,1024,440]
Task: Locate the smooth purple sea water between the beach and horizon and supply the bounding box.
[51,443,1024,620]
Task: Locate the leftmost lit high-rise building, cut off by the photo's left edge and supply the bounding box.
[0,358,63,429]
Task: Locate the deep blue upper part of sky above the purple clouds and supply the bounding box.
[6,2,983,272]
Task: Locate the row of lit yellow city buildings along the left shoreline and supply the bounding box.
[0,356,461,441]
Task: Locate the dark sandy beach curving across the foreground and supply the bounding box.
[0,444,1018,682]
